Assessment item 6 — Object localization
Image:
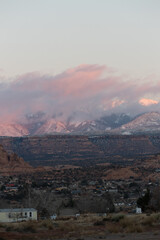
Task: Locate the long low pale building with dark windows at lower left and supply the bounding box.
[0,208,37,222]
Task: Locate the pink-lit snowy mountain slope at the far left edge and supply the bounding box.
[0,123,29,137]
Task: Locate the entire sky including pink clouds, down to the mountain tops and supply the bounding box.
[0,0,160,122]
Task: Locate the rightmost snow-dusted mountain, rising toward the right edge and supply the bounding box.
[112,112,160,134]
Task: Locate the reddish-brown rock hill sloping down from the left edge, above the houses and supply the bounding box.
[0,145,33,175]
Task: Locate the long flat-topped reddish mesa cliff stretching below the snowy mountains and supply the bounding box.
[0,135,160,166]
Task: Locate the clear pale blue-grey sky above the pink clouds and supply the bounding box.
[0,0,160,78]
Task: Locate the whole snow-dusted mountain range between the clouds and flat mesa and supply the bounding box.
[0,112,160,137]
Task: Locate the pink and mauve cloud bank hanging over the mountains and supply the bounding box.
[0,65,160,122]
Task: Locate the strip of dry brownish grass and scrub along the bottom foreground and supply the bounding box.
[0,214,160,240]
